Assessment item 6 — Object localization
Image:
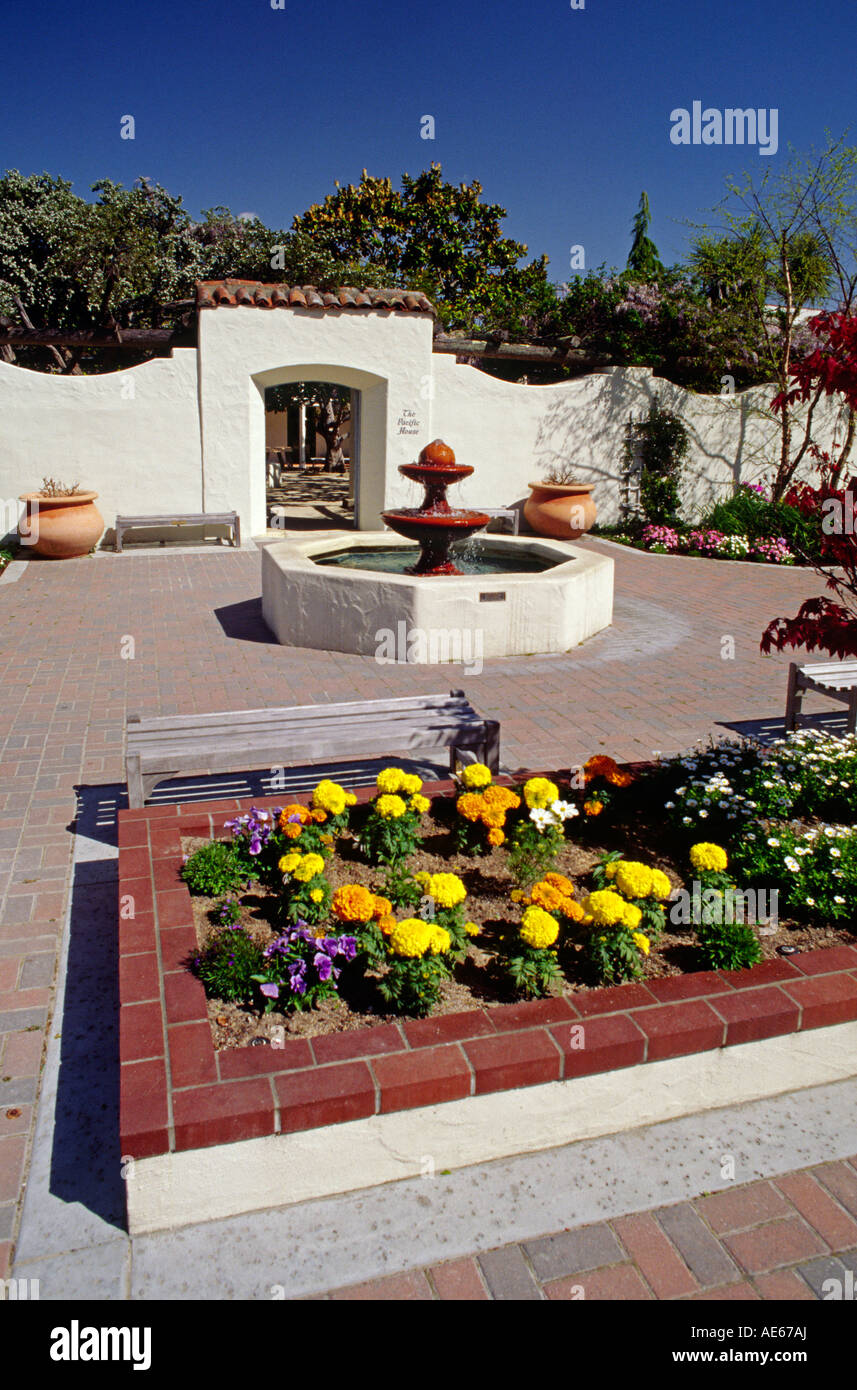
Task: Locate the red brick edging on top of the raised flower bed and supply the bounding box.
[118,783,857,1158]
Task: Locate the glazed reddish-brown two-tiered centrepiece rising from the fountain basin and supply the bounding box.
[381,439,490,575]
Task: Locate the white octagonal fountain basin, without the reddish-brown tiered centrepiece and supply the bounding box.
[263,531,613,664]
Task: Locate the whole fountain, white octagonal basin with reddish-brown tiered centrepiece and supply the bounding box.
[263,439,613,658]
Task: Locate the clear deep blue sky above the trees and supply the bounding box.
[0,0,857,281]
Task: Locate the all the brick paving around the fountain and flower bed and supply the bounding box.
[0,541,857,1298]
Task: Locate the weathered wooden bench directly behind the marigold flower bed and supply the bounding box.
[125,691,500,806]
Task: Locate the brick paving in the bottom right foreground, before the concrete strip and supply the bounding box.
[315,1156,857,1302]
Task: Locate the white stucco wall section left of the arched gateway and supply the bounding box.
[0,348,203,532]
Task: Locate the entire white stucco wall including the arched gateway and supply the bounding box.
[0,306,839,541]
